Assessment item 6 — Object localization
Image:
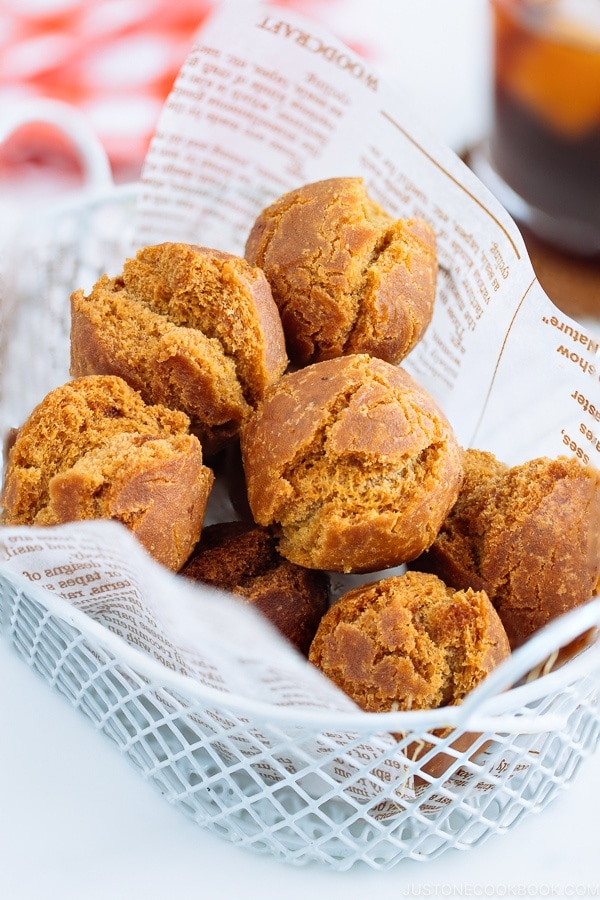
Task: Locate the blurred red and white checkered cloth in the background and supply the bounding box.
[0,0,360,181]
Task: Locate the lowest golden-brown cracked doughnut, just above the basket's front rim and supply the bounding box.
[309,572,510,712]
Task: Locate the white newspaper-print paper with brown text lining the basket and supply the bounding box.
[0,4,600,819]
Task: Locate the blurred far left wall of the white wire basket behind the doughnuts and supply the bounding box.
[0,184,138,435]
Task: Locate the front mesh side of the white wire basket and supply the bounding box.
[0,574,600,870]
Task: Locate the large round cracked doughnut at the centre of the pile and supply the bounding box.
[240,354,462,572]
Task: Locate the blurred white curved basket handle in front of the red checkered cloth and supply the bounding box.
[0,97,113,188]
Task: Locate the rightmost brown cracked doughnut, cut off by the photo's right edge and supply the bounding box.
[411,450,600,647]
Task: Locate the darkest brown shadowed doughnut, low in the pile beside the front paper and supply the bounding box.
[181,522,329,656]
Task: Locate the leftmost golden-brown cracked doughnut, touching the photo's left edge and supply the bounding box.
[2,376,214,570]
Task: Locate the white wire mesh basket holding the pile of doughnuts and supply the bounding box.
[0,156,600,870]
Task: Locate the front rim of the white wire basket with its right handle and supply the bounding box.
[0,566,600,734]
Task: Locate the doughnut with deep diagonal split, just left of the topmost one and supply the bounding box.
[71,243,288,455]
